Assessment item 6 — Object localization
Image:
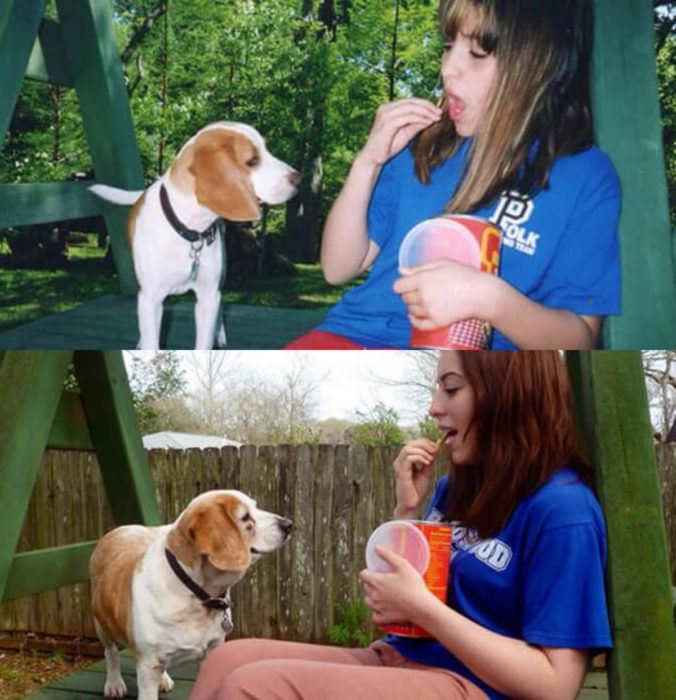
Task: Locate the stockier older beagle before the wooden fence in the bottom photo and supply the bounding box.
[89,491,291,700]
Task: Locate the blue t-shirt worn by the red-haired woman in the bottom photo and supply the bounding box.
[385,467,612,698]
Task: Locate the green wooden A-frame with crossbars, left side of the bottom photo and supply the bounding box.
[0,351,161,601]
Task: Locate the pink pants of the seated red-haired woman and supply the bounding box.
[190,639,487,700]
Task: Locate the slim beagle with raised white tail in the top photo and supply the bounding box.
[89,122,300,350]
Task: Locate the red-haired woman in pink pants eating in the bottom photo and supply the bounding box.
[191,351,611,700]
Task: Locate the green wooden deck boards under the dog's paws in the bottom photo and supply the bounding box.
[26,652,608,700]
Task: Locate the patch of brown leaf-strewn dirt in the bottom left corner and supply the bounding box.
[0,649,94,700]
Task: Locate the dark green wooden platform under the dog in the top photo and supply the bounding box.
[0,295,325,350]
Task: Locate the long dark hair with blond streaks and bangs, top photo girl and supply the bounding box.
[412,0,593,212]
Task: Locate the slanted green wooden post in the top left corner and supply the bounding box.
[0,0,46,145]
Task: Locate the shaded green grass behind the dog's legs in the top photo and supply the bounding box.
[0,235,355,332]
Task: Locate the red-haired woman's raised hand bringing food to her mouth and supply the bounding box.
[392,438,437,518]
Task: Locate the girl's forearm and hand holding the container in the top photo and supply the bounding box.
[394,260,601,350]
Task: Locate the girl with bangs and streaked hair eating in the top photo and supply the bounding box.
[287,0,620,349]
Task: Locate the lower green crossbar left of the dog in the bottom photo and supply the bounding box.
[4,541,96,600]
